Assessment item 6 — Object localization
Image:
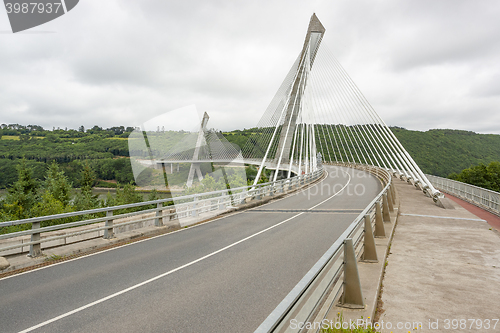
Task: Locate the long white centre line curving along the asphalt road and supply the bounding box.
[19,173,351,333]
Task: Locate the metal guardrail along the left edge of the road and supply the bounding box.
[0,169,323,257]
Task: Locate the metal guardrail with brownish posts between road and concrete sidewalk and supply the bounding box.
[255,164,396,333]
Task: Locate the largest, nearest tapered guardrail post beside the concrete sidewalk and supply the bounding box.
[342,238,365,309]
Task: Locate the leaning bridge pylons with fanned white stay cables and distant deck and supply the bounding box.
[153,14,441,200]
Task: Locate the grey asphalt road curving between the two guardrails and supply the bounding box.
[0,167,381,333]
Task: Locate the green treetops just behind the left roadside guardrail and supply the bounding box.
[0,159,159,234]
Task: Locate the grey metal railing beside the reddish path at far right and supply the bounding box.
[427,175,500,216]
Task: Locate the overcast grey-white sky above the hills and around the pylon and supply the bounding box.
[0,0,500,134]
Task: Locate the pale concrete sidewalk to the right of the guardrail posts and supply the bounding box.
[377,180,500,333]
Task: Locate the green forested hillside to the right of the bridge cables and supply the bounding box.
[391,127,500,177]
